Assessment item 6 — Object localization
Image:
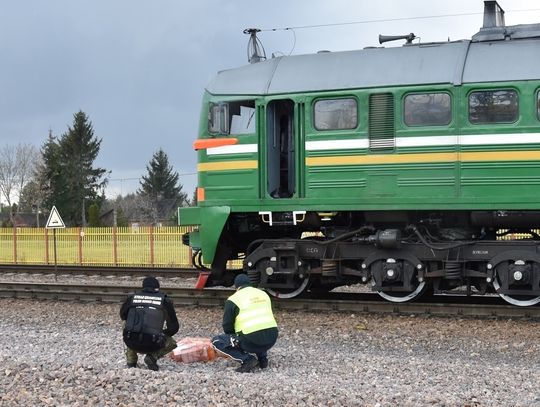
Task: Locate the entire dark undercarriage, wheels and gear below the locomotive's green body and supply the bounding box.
[204,211,540,306]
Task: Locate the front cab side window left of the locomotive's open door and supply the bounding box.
[208,100,255,135]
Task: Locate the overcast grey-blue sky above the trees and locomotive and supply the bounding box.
[0,0,540,202]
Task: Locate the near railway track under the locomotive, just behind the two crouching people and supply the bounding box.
[0,282,540,320]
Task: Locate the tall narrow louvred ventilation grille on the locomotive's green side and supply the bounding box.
[369,93,396,150]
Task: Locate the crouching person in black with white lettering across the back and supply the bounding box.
[120,277,179,370]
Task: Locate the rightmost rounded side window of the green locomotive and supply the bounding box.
[469,90,519,124]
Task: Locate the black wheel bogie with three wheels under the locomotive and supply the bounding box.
[244,230,540,306]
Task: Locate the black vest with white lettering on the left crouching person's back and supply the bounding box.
[123,292,165,353]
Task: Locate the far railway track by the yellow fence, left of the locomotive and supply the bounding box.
[0,264,199,278]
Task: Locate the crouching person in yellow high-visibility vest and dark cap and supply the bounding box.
[212,274,278,373]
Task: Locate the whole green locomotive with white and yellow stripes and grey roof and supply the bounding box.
[179,1,540,306]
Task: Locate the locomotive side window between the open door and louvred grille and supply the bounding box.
[313,99,358,130]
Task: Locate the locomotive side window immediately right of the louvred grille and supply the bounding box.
[403,93,452,126]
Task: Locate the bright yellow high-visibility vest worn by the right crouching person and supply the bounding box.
[229,287,277,335]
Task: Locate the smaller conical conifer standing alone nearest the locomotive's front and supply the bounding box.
[137,149,187,223]
